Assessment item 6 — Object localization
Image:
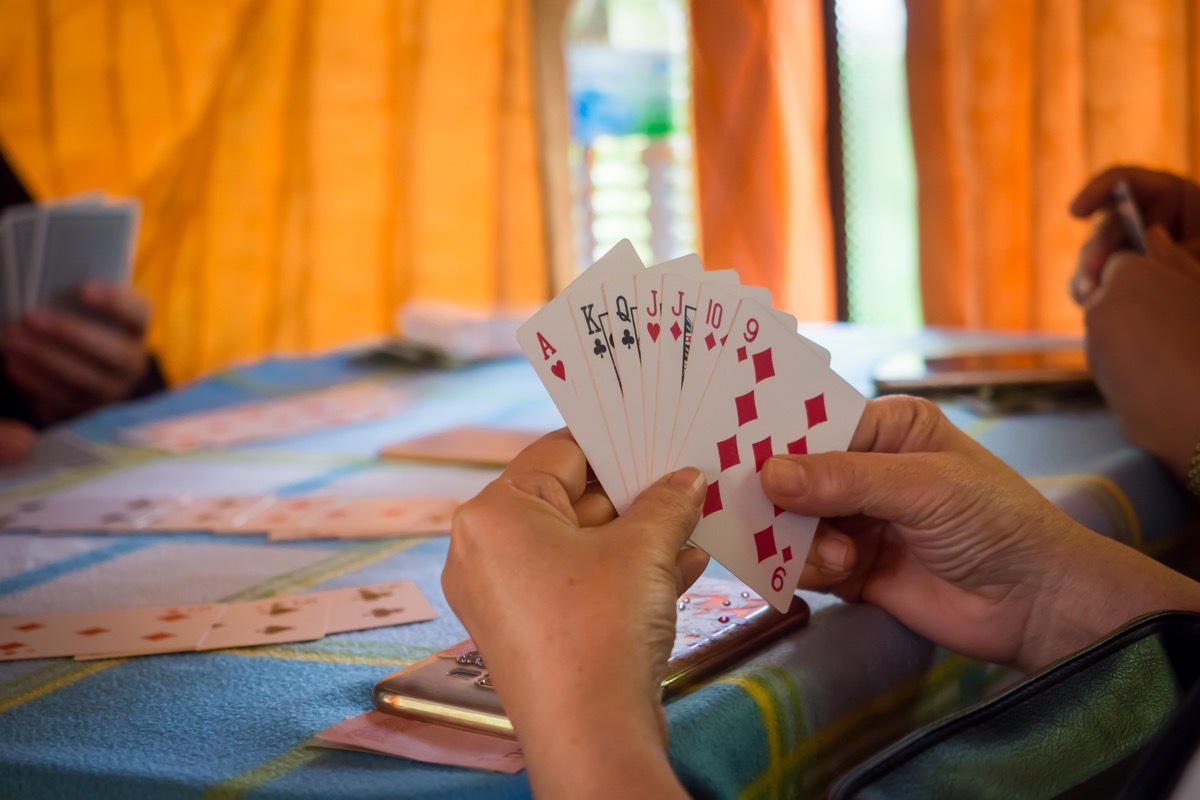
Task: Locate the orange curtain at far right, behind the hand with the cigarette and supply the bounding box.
[908,0,1200,331]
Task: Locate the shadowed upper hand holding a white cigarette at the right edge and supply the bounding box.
[1070,167,1200,306]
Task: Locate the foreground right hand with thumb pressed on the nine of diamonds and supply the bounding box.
[762,396,1200,669]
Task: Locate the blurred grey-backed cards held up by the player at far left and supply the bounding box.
[0,194,138,327]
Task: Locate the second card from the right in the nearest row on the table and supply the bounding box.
[196,594,331,650]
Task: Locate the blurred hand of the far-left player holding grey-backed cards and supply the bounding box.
[4,282,150,425]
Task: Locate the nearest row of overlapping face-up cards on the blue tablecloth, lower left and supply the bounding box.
[0,581,437,661]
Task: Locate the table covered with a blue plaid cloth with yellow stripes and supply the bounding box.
[0,325,1190,798]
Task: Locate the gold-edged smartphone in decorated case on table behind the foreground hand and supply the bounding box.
[374,578,809,739]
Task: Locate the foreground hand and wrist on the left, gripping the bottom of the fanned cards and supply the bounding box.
[442,431,708,796]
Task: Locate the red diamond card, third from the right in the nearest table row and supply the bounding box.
[74,603,222,656]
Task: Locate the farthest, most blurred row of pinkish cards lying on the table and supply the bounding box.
[120,383,412,453]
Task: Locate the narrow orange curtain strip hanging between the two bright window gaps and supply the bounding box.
[691,0,836,319]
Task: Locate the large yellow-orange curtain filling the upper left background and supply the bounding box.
[0,0,552,378]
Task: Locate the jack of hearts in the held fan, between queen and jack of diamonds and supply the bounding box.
[634,254,703,483]
